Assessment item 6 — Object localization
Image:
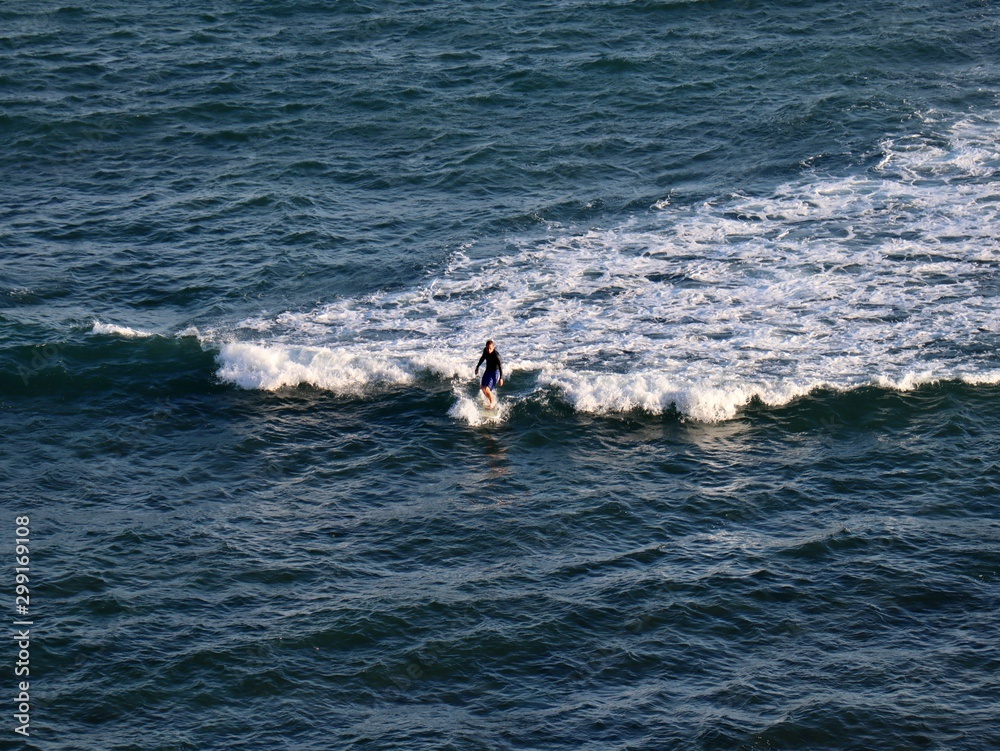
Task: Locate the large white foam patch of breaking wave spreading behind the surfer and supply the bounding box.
[209,111,1000,423]
